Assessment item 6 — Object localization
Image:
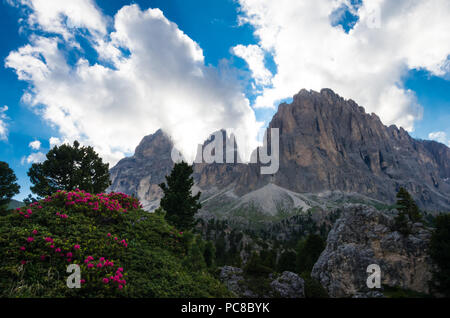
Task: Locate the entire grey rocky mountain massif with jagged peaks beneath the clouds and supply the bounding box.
[110,89,450,216]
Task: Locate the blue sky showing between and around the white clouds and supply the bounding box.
[0,0,450,199]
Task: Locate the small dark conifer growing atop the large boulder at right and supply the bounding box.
[395,187,422,235]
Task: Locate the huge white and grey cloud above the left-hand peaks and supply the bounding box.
[6,0,260,164]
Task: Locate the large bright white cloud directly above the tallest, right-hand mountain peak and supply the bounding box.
[239,0,450,131]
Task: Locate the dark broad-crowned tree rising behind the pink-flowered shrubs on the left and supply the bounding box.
[28,141,111,197]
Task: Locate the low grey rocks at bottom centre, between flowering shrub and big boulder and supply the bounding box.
[220,266,305,298]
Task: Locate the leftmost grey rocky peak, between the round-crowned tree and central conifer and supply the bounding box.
[108,129,174,211]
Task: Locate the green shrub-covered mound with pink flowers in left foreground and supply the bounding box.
[0,191,230,297]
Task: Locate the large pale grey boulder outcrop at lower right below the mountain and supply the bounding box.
[312,205,432,297]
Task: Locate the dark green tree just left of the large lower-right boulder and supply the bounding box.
[297,234,325,273]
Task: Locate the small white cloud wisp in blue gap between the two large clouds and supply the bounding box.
[232,45,272,85]
